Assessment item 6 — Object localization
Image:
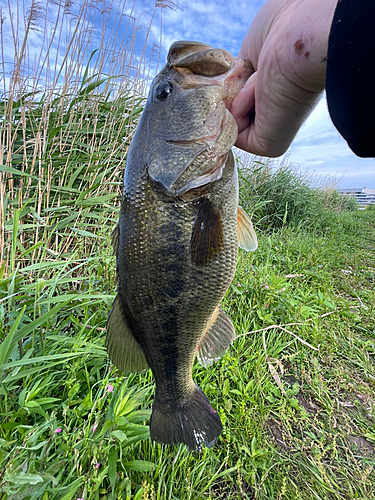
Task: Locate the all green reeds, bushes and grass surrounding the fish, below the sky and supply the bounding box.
[0,4,375,500]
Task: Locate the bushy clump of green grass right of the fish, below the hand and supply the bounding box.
[237,155,358,233]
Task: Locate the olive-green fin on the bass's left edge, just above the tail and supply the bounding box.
[106,294,148,373]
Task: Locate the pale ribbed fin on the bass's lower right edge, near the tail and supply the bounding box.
[197,305,236,367]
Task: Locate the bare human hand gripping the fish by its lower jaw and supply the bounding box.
[231,0,337,157]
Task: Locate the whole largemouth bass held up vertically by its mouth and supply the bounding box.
[107,42,257,451]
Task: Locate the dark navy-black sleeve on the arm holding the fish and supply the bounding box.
[323,0,375,157]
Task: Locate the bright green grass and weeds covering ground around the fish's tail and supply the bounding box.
[0,210,375,500]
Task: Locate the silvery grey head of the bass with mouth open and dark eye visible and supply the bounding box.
[143,42,251,198]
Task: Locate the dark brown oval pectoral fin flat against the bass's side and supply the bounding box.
[190,200,224,266]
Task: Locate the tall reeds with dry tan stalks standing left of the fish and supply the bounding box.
[0,0,172,410]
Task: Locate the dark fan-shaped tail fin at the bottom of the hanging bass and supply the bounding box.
[150,386,222,451]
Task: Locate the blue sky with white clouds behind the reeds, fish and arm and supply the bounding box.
[0,0,375,187]
